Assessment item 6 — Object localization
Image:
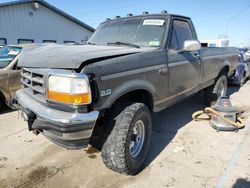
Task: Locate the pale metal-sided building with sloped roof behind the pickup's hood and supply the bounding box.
[0,0,94,45]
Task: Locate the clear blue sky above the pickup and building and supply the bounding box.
[0,0,250,46]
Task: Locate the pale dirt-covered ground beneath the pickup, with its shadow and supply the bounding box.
[0,81,250,188]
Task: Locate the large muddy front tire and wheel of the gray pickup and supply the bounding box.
[102,103,152,175]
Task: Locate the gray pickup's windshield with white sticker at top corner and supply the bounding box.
[88,17,166,47]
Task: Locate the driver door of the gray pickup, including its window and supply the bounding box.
[168,18,201,98]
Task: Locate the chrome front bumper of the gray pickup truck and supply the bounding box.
[16,90,99,149]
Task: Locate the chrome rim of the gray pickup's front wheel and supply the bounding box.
[129,120,145,158]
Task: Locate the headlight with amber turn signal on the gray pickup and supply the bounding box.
[48,76,91,105]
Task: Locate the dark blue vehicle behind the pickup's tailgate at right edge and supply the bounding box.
[228,50,250,86]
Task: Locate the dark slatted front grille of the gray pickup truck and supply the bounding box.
[21,69,45,100]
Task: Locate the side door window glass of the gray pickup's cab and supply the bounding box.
[169,20,194,49]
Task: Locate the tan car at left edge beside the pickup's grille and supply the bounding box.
[0,44,38,111]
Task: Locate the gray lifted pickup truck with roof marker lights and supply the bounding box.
[17,13,238,175]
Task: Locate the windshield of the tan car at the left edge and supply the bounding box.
[0,46,22,69]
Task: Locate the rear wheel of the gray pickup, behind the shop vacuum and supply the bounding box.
[204,74,227,106]
